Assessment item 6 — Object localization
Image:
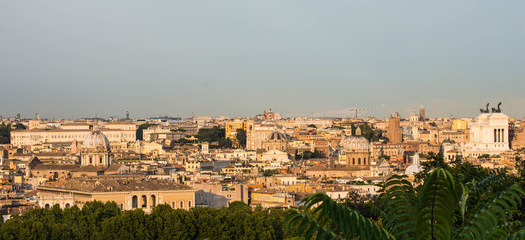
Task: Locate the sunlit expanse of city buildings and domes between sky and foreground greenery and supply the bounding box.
[0,103,525,238]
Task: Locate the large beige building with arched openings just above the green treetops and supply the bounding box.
[37,175,195,213]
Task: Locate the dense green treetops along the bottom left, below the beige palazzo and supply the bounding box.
[0,201,295,239]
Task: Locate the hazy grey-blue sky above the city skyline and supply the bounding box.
[0,0,525,119]
